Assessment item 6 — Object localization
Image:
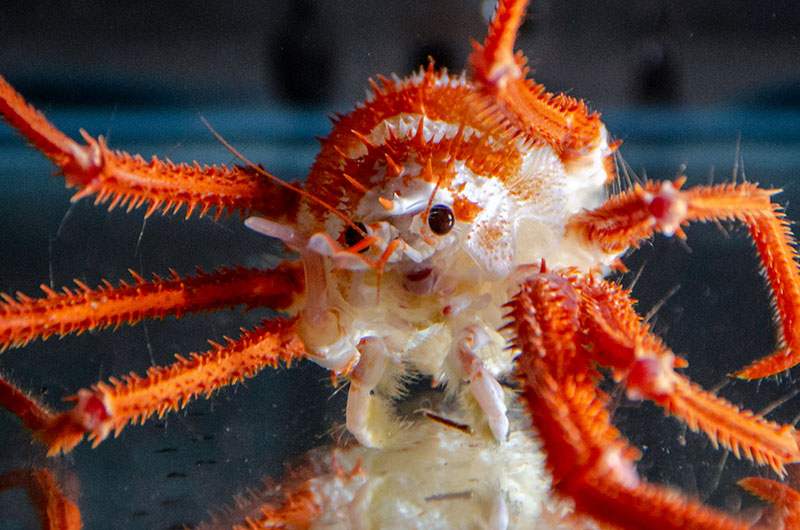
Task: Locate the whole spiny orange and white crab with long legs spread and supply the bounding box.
[0,0,800,529]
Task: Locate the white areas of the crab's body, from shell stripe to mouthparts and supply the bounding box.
[250,107,617,447]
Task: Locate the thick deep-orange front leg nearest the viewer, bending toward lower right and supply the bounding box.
[508,272,800,530]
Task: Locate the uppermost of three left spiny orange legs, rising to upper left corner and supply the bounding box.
[0,73,299,219]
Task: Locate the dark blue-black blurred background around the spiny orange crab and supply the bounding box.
[0,0,800,530]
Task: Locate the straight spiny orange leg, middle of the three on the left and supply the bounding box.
[0,262,304,351]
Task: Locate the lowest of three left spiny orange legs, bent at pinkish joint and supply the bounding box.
[0,319,305,455]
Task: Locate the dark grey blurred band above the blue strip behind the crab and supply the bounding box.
[0,0,800,109]
